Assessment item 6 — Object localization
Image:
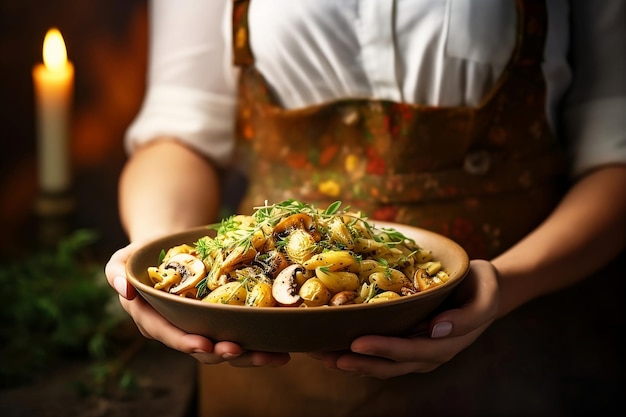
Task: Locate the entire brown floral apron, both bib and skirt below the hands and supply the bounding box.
[198,0,620,417]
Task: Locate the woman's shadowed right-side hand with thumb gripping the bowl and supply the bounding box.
[311,260,499,379]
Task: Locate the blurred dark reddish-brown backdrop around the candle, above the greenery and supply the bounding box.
[0,0,147,259]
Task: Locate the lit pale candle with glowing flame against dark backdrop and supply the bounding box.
[33,28,74,194]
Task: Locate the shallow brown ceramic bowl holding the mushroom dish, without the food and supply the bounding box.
[126,221,469,352]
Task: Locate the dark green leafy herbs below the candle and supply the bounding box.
[0,230,120,389]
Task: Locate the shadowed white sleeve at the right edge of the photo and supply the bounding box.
[563,0,626,176]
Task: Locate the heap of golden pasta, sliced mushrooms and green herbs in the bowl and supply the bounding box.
[147,200,450,307]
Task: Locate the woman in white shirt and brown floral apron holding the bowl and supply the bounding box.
[106,0,626,416]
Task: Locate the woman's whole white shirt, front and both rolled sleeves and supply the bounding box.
[126,0,626,175]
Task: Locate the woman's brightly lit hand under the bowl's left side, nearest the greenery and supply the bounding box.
[105,243,290,367]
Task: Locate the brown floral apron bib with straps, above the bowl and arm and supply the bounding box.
[233,1,564,258]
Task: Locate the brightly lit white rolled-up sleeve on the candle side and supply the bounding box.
[125,0,236,165]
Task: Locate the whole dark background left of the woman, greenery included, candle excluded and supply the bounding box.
[0,4,196,417]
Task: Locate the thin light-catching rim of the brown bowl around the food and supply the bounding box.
[125,220,469,314]
